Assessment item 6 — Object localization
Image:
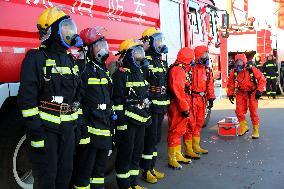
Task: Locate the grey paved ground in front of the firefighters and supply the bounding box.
[108,97,284,189]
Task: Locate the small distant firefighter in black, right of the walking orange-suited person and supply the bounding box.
[263,54,278,99]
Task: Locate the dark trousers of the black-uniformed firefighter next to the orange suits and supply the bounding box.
[140,113,164,170]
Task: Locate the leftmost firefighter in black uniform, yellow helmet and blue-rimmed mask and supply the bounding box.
[18,7,82,189]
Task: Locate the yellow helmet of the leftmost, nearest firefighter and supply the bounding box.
[38,7,67,29]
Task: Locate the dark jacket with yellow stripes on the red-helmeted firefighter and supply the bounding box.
[78,60,113,149]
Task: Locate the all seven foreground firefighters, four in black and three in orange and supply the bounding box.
[15,7,265,189]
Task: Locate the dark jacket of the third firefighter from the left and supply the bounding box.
[112,52,151,130]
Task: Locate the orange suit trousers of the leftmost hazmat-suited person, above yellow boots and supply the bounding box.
[168,101,189,147]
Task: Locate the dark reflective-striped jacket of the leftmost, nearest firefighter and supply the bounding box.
[18,44,80,147]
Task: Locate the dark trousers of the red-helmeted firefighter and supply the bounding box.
[72,144,109,189]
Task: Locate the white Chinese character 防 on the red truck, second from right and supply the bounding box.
[107,0,124,21]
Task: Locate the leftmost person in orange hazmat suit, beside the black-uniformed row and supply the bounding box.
[168,47,194,169]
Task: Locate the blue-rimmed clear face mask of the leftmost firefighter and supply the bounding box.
[58,19,83,48]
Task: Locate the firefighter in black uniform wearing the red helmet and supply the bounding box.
[73,28,113,189]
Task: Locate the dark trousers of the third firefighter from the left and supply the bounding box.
[115,125,145,189]
